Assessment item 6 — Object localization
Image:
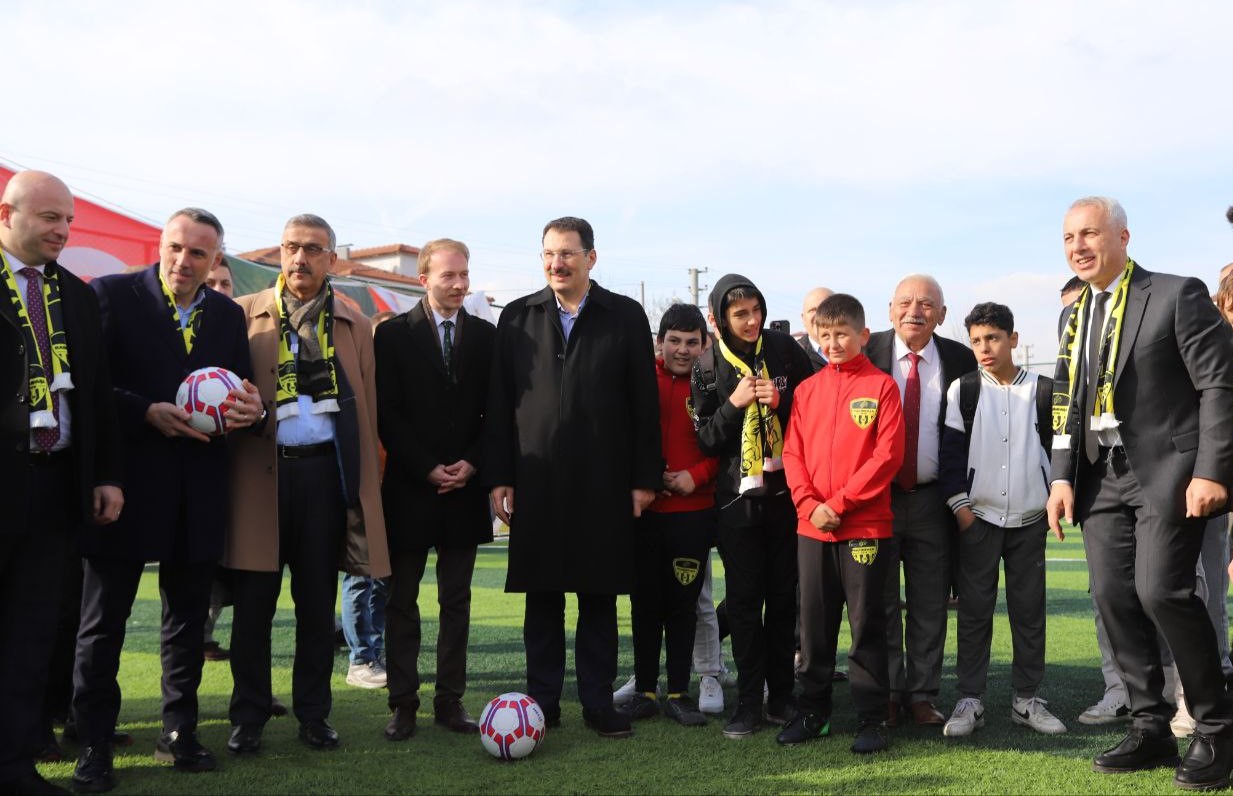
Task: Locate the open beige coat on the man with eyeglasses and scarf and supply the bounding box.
[223,288,390,578]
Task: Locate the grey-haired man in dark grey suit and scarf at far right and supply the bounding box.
[1048,197,1233,790]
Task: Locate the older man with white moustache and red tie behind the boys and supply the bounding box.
[864,274,977,727]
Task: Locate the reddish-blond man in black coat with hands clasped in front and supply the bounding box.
[374,239,496,741]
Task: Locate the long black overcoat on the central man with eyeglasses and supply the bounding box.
[485,282,663,594]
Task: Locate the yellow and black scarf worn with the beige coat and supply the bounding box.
[274,274,338,420]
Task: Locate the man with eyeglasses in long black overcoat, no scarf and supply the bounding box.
[486,217,663,737]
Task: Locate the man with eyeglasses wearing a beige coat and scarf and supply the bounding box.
[223,213,390,754]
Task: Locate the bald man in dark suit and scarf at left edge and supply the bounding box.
[0,171,125,794]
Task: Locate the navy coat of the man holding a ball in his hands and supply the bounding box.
[81,265,252,563]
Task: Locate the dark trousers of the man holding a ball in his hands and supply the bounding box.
[73,557,217,745]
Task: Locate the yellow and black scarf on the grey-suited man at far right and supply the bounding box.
[1053,259,1136,450]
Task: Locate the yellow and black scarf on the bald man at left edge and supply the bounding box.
[0,250,73,429]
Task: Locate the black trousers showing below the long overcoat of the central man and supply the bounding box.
[523,591,617,718]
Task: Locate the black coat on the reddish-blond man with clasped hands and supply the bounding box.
[374,302,497,553]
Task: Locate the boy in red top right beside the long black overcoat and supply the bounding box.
[618,304,719,727]
